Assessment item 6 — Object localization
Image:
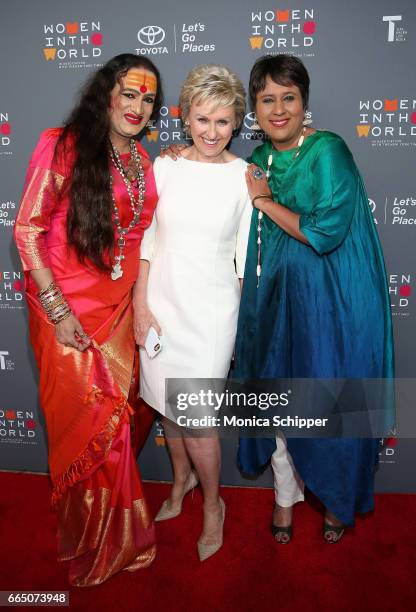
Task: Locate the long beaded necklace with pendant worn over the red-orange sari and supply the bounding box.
[110,139,146,281]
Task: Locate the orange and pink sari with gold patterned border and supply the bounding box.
[15,129,157,586]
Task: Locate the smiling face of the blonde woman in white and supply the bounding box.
[186,101,236,163]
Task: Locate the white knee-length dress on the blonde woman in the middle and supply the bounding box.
[140,157,253,415]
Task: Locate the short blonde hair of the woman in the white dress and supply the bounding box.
[179,64,246,128]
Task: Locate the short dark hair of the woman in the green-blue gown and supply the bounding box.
[248,54,309,110]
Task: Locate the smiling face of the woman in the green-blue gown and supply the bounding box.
[255,76,305,151]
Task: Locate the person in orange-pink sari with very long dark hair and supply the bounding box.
[15,54,162,586]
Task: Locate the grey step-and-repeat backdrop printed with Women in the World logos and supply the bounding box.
[0,0,416,492]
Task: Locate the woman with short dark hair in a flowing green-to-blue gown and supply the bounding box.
[234,55,393,543]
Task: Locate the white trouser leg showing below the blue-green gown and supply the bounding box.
[271,431,304,508]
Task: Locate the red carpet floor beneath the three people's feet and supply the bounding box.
[0,473,416,612]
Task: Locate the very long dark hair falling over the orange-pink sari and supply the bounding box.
[55,53,163,270]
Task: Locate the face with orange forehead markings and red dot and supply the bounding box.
[110,68,157,153]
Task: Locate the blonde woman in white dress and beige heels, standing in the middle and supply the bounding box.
[134,64,252,561]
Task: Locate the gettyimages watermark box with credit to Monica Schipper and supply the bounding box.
[165,378,398,438]
